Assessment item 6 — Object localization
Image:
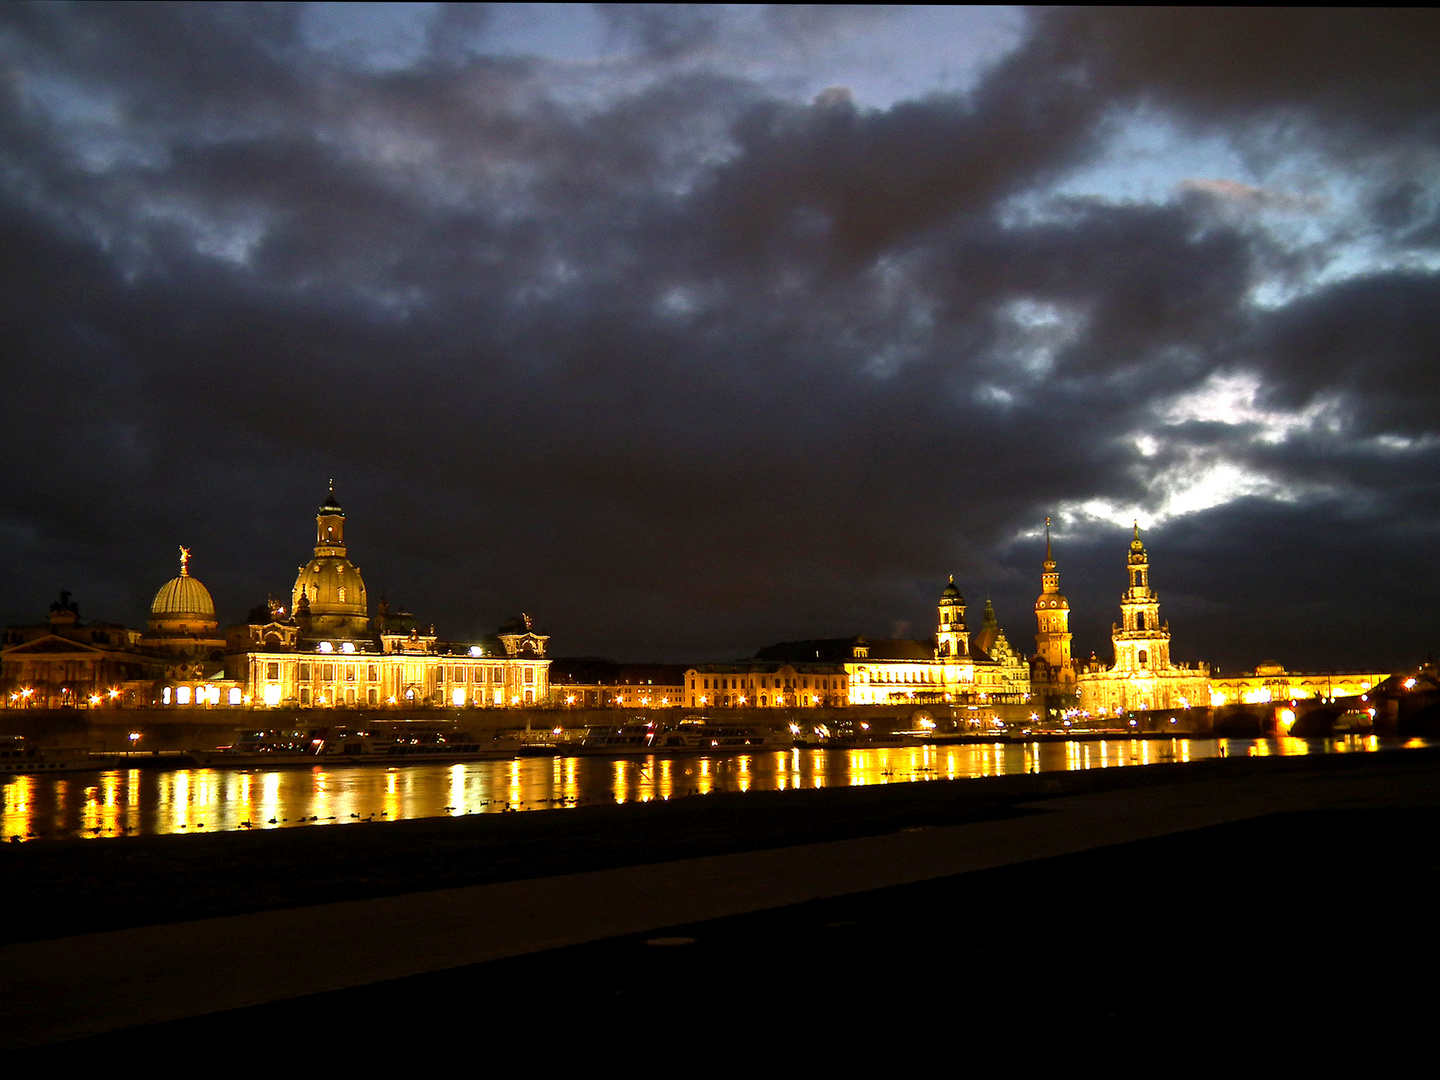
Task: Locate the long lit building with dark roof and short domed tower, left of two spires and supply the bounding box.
[743,577,1030,706]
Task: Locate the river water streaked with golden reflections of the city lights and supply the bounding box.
[0,736,1428,840]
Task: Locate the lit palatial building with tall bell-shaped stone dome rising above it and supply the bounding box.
[226,488,550,708]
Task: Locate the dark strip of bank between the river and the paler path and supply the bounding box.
[0,747,1440,942]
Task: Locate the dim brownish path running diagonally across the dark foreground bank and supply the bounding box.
[0,753,1440,1047]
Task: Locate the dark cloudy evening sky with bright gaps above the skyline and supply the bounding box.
[0,4,1440,671]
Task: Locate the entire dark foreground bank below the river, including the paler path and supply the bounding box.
[11,750,1440,1059]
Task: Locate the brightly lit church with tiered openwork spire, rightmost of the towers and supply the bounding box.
[1077,523,1210,716]
